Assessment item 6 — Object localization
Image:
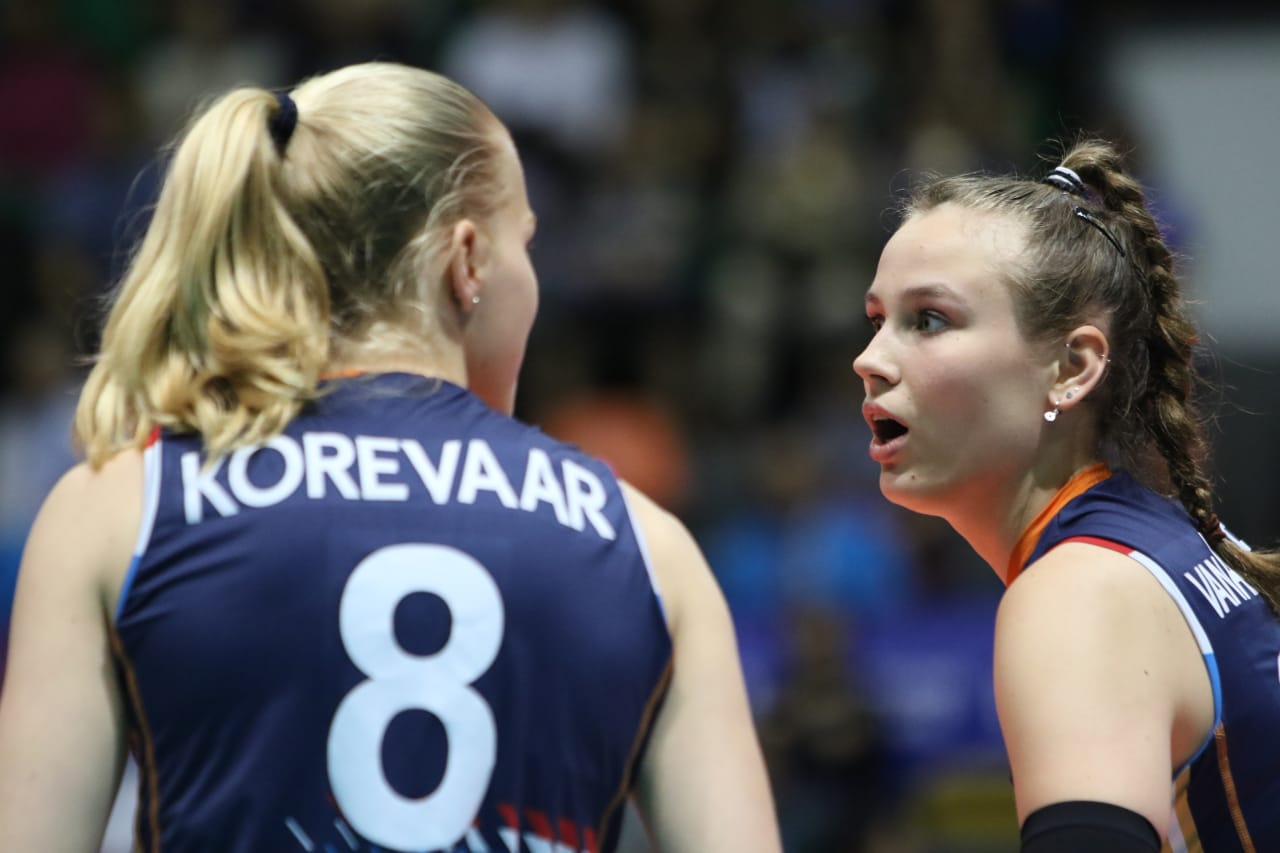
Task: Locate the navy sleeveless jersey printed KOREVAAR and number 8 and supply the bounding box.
[113,374,672,853]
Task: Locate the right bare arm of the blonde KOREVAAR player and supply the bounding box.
[627,488,781,852]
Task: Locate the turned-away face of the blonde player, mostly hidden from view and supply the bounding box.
[465,131,538,414]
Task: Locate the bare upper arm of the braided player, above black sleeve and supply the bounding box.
[995,543,1198,836]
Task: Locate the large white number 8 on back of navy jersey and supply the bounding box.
[328,544,503,850]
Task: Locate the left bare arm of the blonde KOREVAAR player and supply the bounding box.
[0,458,131,850]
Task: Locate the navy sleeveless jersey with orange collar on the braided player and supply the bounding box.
[1028,473,1280,853]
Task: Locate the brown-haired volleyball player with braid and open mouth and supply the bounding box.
[854,141,1280,853]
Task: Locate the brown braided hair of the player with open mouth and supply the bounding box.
[905,141,1280,612]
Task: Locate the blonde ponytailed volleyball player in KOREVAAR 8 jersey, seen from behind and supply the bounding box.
[0,64,780,853]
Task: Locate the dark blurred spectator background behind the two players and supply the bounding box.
[0,0,1280,853]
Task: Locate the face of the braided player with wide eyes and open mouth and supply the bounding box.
[854,204,1056,517]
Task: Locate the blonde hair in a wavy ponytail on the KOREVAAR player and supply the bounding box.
[74,63,502,467]
